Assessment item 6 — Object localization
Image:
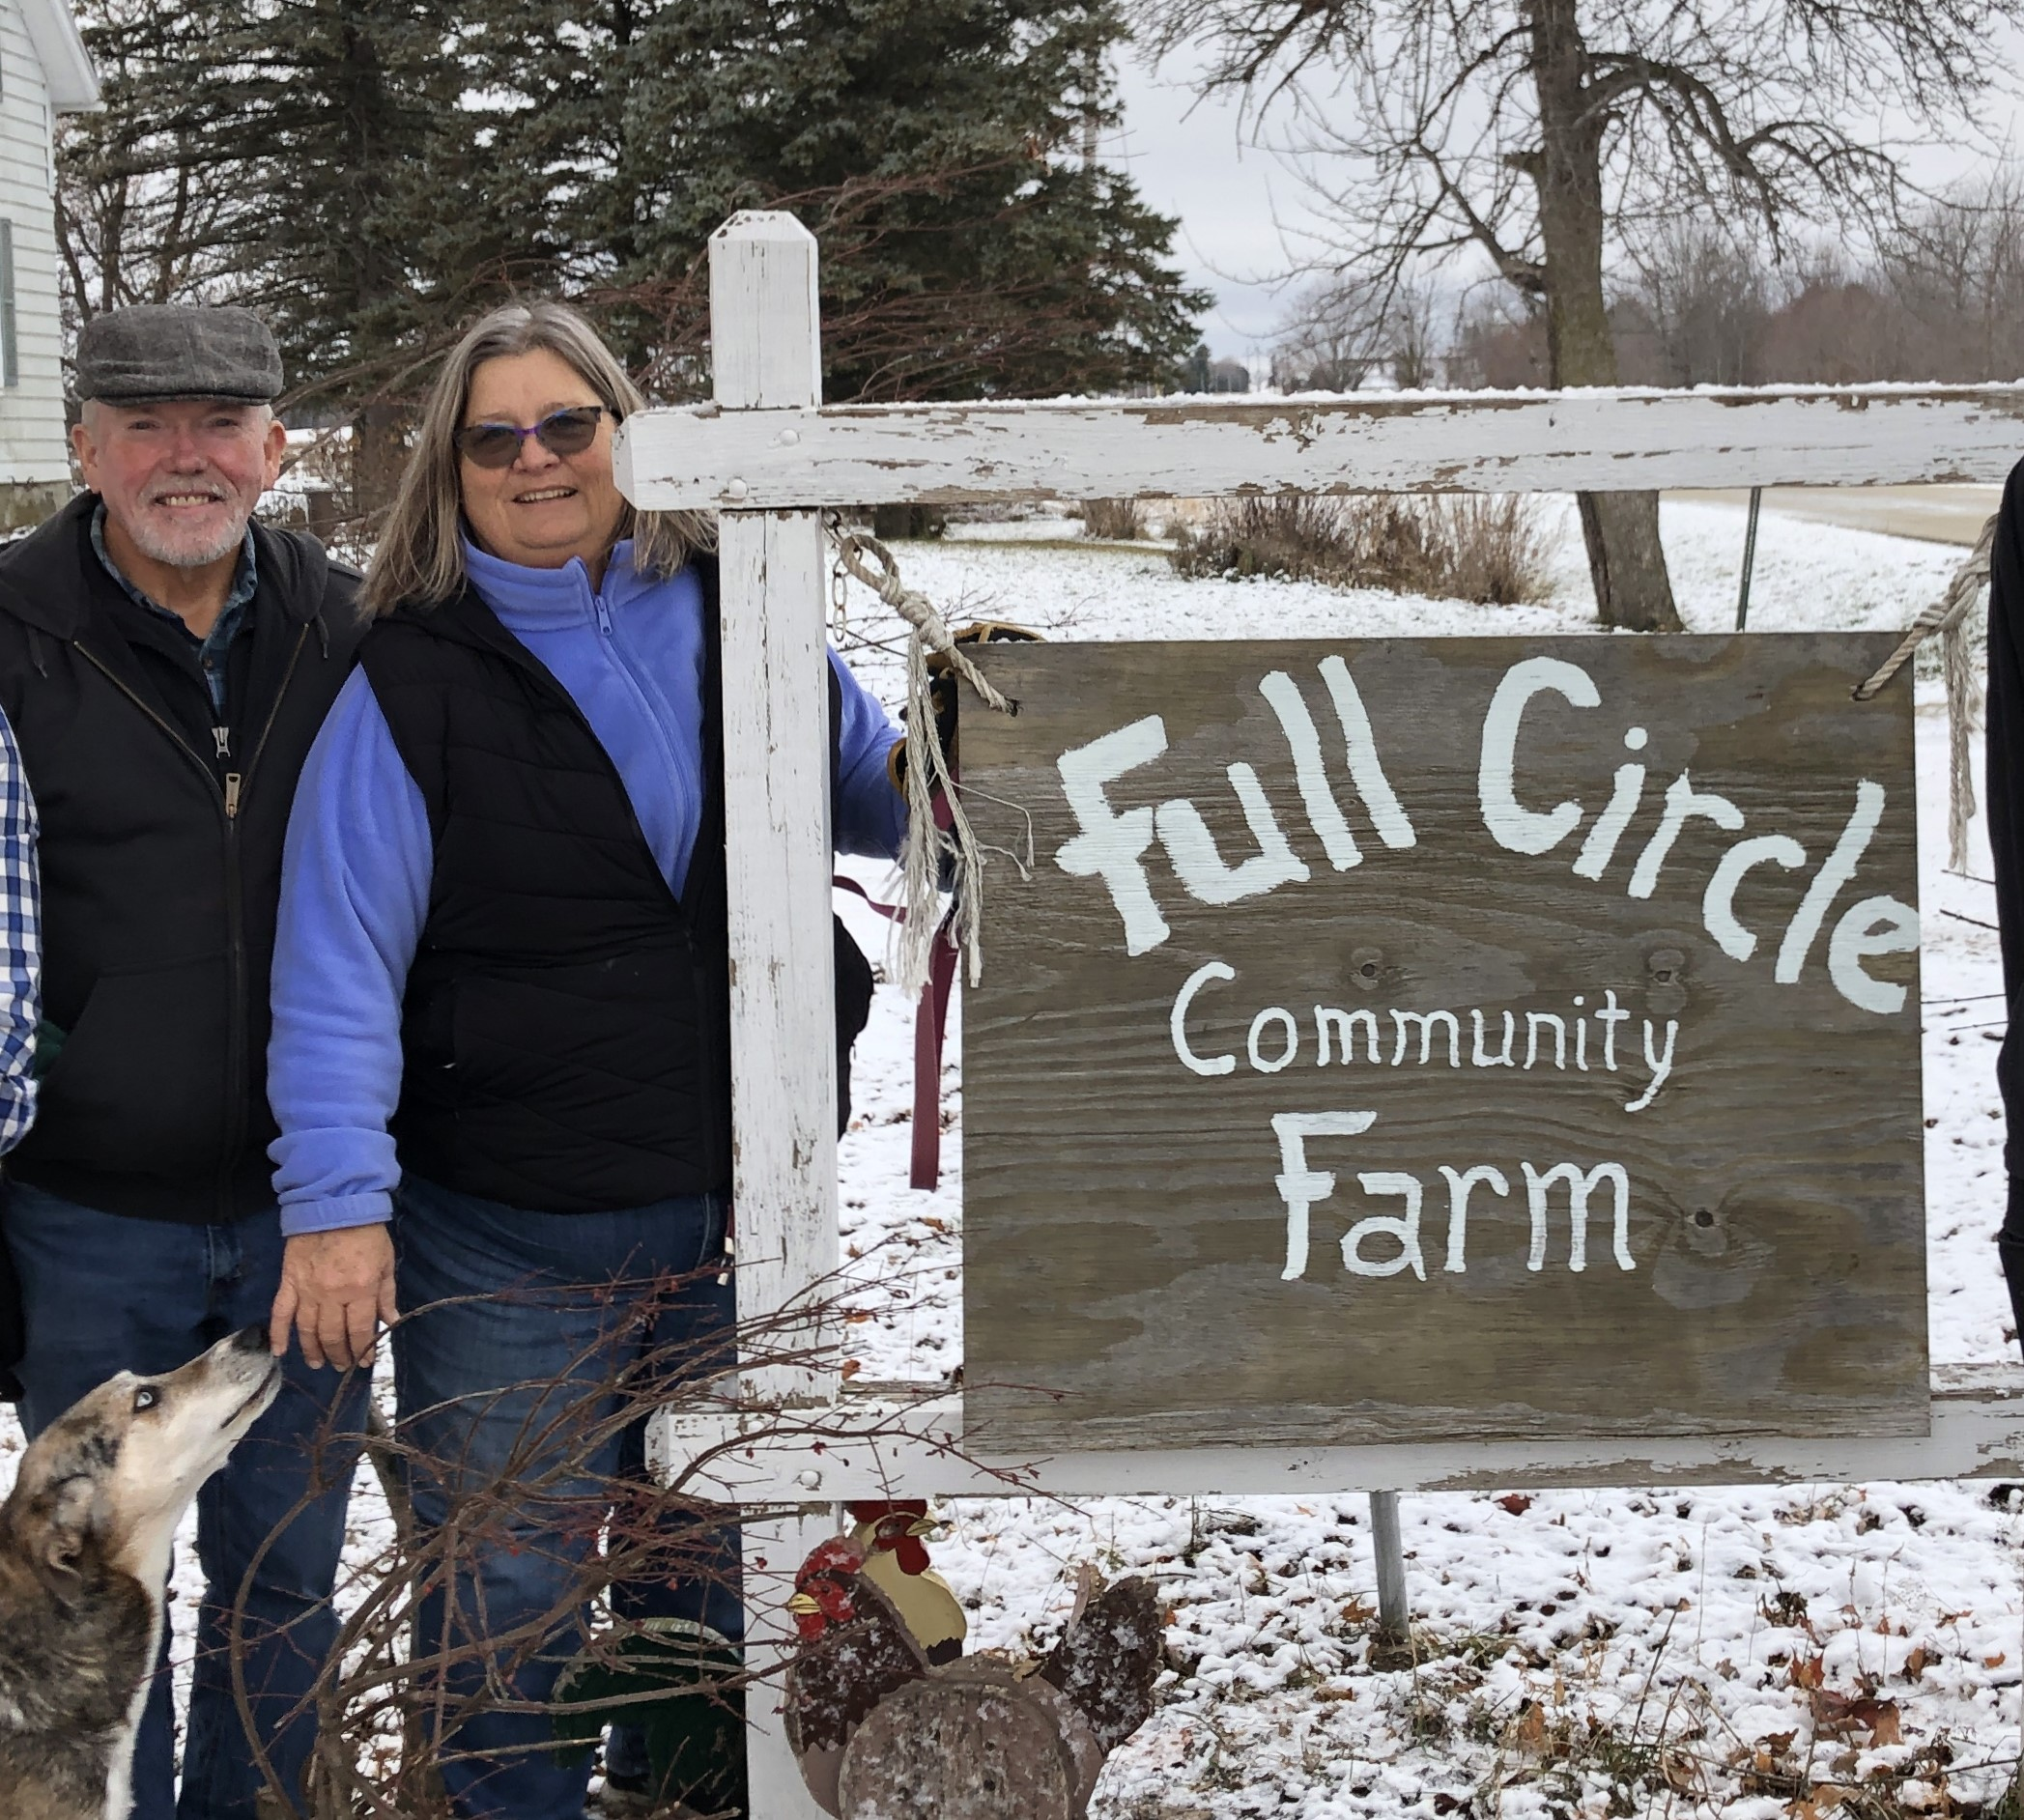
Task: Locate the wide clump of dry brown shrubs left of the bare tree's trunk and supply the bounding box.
[1172,494,1551,606]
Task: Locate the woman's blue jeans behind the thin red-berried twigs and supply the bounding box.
[392,1177,743,1820]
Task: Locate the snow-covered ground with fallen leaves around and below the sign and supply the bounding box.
[0,502,2024,1820]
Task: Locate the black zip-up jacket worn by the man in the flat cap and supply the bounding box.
[0,494,362,1223]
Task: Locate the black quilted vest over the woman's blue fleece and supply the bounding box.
[358,560,870,1212]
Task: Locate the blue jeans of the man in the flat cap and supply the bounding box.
[0,1182,366,1820]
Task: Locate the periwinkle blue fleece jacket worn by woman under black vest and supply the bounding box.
[268,543,907,1233]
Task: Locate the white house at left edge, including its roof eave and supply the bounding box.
[0,0,101,530]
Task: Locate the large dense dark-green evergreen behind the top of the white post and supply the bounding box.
[466,0,1207,399]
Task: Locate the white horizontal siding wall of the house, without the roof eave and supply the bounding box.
[0,0,71,488]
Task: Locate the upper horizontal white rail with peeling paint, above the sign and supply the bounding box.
[617,384,2024,510]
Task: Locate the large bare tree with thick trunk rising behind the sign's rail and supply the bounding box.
[1139,0,2024,630]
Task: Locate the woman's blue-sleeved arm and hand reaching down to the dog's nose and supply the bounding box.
[268,672,433,1369]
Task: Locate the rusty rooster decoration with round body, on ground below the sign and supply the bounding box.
[785,1504,1164,1820]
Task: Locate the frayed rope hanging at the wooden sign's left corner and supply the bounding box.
[836,530,1018,994]
